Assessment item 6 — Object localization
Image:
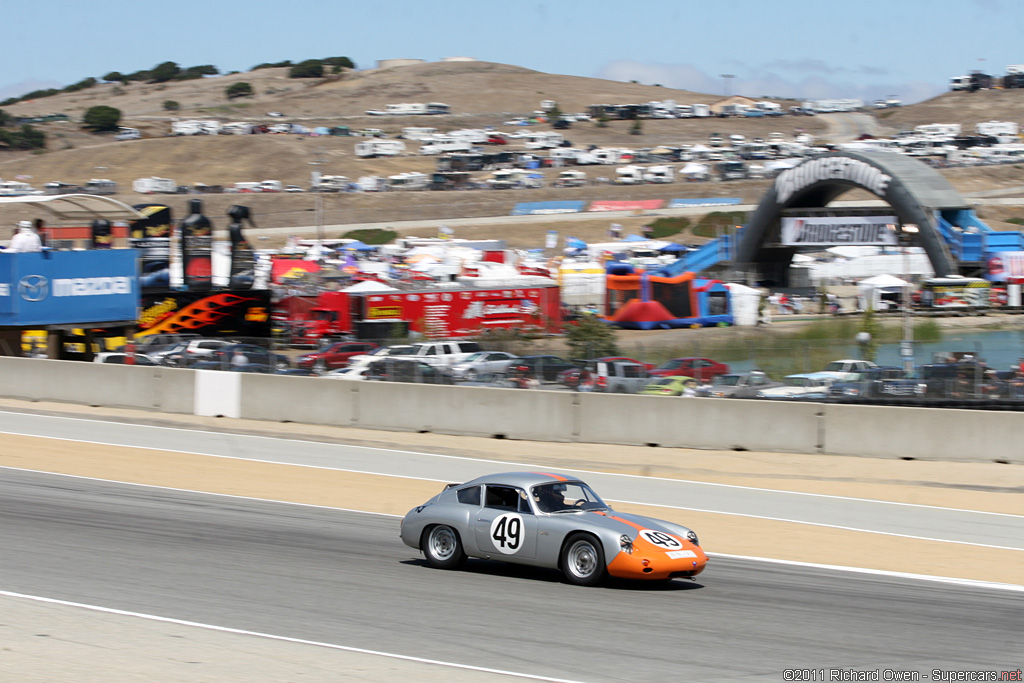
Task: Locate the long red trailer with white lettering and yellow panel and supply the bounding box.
[362,287,558,339]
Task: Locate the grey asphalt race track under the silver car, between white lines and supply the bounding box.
[0,470,1024,681]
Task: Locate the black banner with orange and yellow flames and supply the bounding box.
[136,290,270,337]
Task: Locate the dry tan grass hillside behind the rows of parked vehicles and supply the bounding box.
[0,61,1024,248]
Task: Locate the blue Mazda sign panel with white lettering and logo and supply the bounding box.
[0,249,139,326]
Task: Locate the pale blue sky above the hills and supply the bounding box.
[0,0,1024,103]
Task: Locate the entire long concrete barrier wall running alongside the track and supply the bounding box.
[0,357,1024,464]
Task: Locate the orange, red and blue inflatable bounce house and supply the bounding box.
[604,262,733,330]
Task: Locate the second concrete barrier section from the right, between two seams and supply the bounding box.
[579,393,821,453]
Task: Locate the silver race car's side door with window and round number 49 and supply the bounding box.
[472,484,537,562]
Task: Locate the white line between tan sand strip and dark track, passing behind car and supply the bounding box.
[0,466,1024,594]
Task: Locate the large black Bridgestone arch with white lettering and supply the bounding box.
[735,152,968,280]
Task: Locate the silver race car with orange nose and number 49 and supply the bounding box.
[400,472,708,586]
